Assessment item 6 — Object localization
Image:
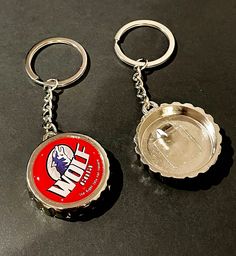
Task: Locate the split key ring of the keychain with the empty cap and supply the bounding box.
[114,20,175,68]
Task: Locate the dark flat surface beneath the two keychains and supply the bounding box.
[0,0,236,256]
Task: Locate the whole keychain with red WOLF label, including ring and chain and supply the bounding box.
[25,37,110,220]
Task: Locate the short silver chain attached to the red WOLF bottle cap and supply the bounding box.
[43,79,58,140]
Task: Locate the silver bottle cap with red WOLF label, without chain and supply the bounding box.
[27,133,110,219]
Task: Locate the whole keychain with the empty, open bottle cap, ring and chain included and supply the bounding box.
[114,20,222,179]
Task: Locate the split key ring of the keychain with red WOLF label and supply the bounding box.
[25,37,87,88]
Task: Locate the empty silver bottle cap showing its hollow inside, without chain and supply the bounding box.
[135,102,222,179]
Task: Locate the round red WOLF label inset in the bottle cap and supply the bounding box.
[33,136,104,203]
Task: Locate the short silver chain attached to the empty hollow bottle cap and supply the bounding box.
[133,58,158,114]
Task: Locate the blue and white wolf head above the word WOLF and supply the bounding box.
[51,146,71,176]
